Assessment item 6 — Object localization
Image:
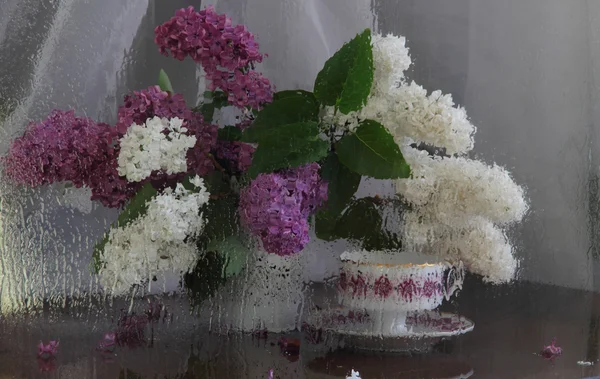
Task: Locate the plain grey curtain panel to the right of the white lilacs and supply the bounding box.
[465,1,600,288]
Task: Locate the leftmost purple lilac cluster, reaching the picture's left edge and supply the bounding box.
[3,110,116,187]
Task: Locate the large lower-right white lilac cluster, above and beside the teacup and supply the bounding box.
[396,146,528,283]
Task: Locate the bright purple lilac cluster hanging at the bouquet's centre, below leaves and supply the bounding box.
[239,163,327,256]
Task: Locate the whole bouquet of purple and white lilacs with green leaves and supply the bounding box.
[3,7,526,299]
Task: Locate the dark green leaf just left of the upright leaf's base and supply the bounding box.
[242,91,319,142]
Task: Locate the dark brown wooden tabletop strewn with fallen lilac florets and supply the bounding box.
[0,277,600,379]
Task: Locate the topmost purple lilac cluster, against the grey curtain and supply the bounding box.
[154,6,273,109]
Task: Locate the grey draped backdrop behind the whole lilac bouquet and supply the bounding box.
[0,0,600,310]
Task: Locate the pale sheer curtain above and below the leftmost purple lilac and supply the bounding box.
[0,0,178,311]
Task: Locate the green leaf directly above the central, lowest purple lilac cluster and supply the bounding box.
[247,122,329,178]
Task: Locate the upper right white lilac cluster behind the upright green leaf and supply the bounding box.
[321,35,476,154]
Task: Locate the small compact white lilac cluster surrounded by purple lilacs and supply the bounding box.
[118,116,196,182]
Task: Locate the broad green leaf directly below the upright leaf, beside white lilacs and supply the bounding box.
[335,120,410,179]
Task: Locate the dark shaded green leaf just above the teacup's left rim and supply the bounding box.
[334,197,402,251]
